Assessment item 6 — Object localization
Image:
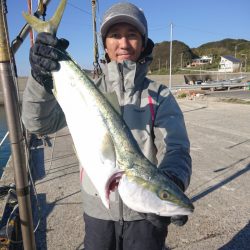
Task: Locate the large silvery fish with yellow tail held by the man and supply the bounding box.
[23,0,194,216]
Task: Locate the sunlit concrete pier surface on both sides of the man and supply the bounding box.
[0,84,250,250]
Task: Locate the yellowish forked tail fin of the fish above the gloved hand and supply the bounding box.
[22,0,67,35]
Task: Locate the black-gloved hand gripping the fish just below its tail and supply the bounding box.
[29,32,69,93]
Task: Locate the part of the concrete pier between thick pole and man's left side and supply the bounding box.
[29,128,84,249]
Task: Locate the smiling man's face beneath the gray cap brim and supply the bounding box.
[105,23,144,62]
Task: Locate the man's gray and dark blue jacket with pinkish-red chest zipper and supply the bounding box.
[22,57,191,221]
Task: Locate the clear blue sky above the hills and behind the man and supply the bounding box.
[7,0,250,76]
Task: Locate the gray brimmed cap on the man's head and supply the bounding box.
[100,3,148,46]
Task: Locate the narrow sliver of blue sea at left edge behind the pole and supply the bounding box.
[0,105,10,176]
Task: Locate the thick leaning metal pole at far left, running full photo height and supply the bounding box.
[0,0,36,250]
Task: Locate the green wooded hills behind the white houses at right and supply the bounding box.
[150,38,250,73]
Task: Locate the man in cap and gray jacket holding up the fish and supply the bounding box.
[22,3,191,250]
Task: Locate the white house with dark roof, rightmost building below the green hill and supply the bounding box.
[219,56,241,73]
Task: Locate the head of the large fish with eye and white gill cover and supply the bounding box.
[118,170,194,216]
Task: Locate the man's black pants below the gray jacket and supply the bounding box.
[84,214,167,250]
